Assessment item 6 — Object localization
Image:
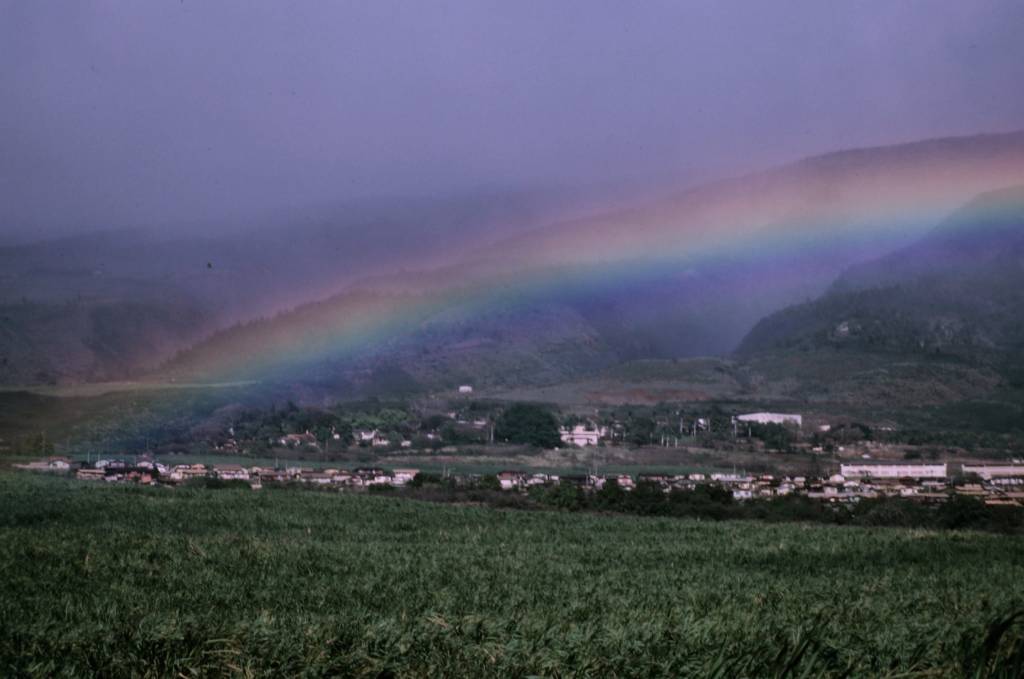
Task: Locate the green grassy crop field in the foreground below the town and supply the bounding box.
[0,472,1024,677]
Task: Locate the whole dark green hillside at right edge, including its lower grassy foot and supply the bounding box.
[737,188,1024,419]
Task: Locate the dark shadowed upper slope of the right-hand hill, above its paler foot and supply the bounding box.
[738,188,1024,383]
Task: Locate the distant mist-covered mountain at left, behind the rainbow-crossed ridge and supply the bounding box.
[0,189,606,384]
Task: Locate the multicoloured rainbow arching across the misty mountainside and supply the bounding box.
[162,134,1024,381]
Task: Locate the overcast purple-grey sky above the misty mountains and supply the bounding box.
[0,0,1024,241]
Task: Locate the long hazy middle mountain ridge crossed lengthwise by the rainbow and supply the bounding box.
[161,133,1024,395]
